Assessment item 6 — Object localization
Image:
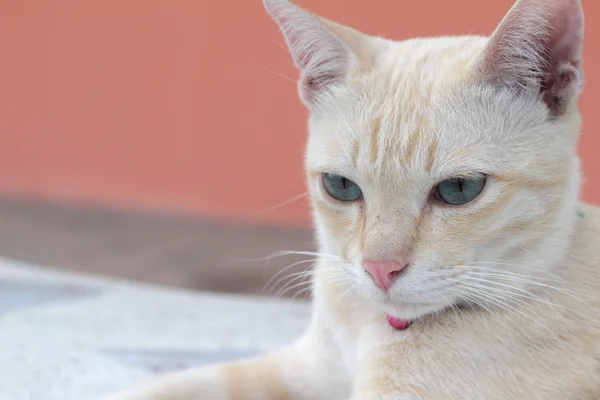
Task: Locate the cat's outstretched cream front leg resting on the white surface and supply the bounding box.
[104,328,350,400]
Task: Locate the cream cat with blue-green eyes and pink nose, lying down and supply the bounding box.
[104,0,600,400]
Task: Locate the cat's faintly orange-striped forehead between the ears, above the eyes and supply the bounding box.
[307,37,556,181]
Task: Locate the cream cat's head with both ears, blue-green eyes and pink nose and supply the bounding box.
[265,0,583,319]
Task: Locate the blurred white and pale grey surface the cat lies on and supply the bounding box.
[0,257,310,400]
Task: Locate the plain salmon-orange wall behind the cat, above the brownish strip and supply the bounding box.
[0,0,600,223]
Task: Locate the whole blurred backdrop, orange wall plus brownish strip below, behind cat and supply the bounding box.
[0,0,600,296]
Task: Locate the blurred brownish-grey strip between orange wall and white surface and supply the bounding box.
[0,199,314,297]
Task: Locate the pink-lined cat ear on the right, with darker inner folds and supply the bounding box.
[478,0,583,116]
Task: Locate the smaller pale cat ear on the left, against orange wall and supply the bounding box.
[264,0,369,109]
